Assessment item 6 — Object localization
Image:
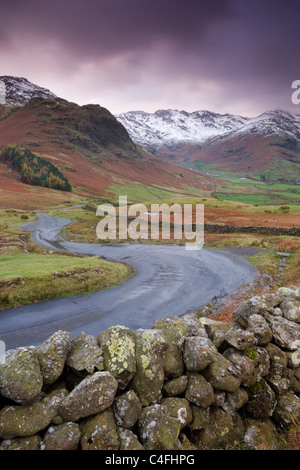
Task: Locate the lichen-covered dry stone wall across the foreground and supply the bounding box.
[0,287,300,451]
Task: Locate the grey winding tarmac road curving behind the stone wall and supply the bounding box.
[0,214,256,349]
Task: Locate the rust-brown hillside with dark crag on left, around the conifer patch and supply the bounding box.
[0,77,212,209]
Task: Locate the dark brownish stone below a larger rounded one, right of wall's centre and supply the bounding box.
[185,372,215,408]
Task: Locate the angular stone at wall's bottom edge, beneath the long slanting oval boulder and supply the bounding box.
[80,408,120,450]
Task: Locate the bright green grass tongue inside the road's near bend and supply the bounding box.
[0,254,133,309]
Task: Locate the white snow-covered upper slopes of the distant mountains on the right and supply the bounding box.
[116,109,300,149]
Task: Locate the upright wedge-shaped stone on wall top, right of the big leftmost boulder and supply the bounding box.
[36,330,71,384]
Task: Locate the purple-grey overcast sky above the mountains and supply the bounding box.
[0,0,300,116]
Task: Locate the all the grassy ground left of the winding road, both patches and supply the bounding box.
[0,210,133,309]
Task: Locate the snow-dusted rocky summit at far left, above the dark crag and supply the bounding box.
[0,75,57,106]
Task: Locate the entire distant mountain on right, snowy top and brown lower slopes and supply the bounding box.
[117,110,300,183]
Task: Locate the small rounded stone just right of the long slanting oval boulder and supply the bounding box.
[113,390,142,428]
